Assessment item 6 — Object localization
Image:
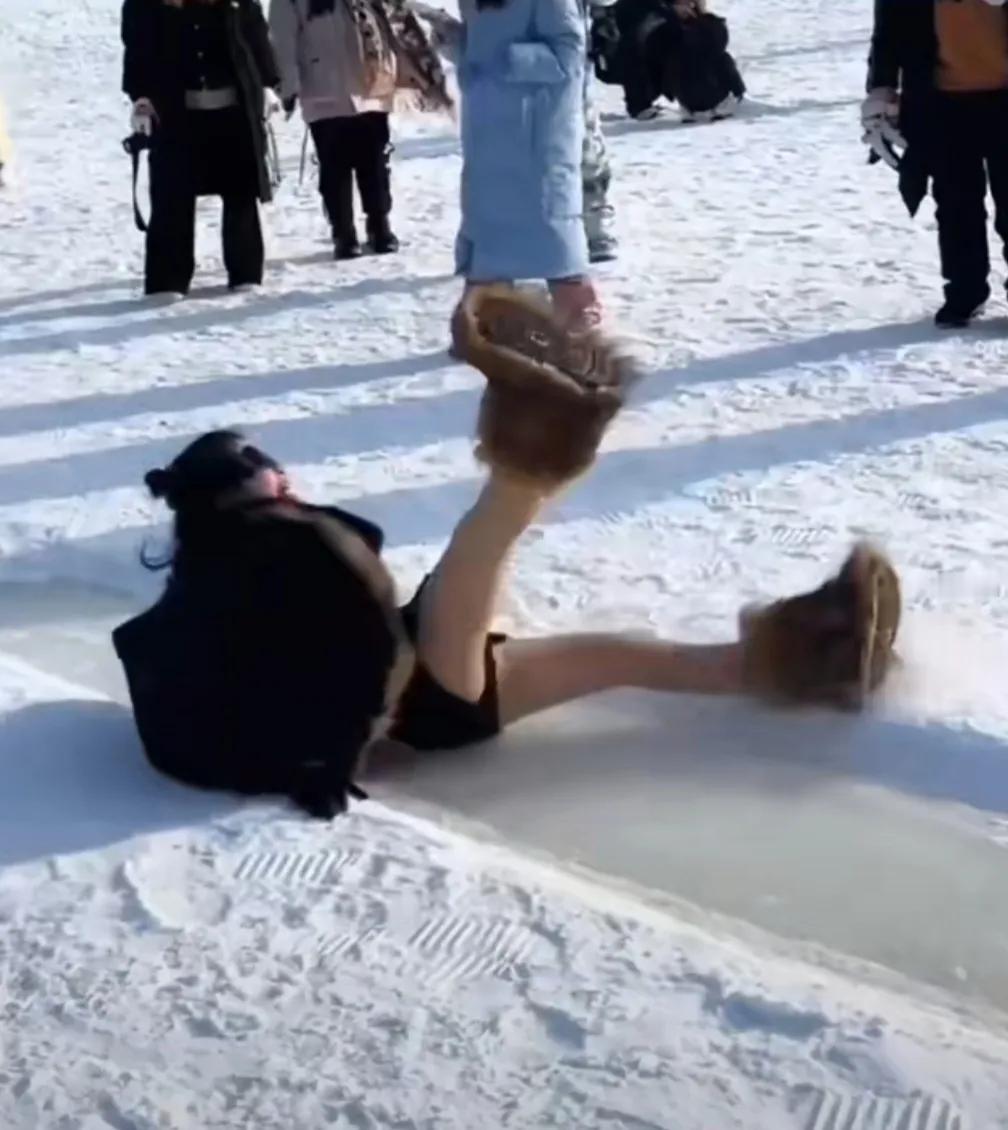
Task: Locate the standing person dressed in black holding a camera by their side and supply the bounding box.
[122,0,280,295]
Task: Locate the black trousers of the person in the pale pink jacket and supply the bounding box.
[311,113,392,236]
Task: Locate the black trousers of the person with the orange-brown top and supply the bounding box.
[929,90,1008,305]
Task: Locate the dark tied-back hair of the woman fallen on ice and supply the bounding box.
[140,431,280,570]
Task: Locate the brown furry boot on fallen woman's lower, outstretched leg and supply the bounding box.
[739,542,901,711]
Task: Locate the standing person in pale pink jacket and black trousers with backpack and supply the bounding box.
[269,0,452,259]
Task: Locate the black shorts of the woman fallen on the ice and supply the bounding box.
[389,579,507,749]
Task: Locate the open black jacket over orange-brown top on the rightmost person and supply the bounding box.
[866,0,1008,215]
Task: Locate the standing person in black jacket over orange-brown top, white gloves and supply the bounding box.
[861,0,1008,328]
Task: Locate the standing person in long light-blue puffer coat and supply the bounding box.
[453,0,601,334]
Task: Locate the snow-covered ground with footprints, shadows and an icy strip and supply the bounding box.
[0,0,1008,1130]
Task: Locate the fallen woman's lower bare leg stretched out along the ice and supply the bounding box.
[497,635,745,725]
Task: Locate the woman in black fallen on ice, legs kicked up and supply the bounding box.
[114,288,900,818]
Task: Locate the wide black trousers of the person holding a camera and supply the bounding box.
[144,110,264,294]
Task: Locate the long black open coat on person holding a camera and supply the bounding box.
[122,0,280,202]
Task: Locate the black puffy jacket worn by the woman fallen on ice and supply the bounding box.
[113,503,401,815]
